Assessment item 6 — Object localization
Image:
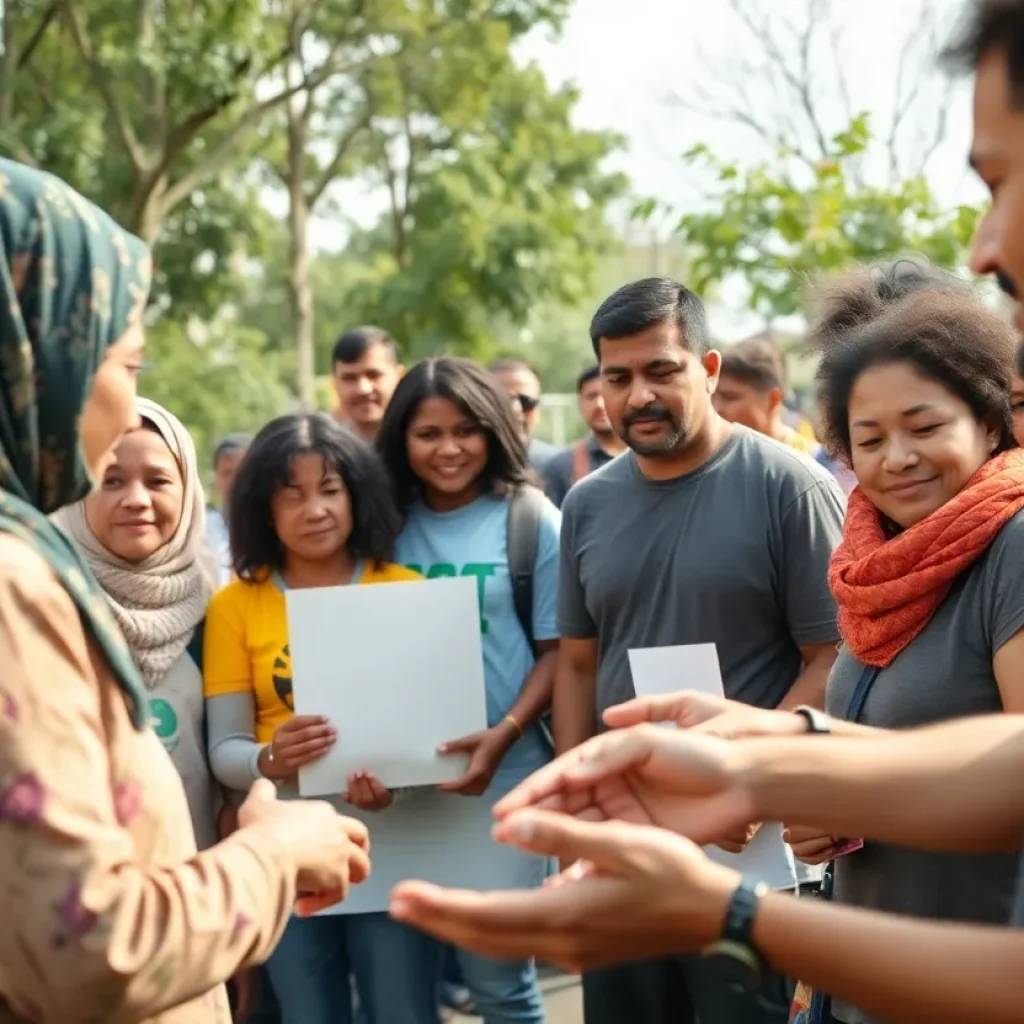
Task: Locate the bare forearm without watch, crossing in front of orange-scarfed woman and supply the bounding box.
[735,715,1024,852]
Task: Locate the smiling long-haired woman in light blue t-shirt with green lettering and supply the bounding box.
[377,357,560,1024]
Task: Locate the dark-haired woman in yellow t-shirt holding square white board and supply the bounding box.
[204,415,439,1024]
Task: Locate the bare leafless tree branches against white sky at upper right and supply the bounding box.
[669,0,953,188]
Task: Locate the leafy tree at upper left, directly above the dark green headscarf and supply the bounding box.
[0,0,362,314]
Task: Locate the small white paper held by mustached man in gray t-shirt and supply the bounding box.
[629,643,797,889]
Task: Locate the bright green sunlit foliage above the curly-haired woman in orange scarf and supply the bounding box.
[679,114,979,323]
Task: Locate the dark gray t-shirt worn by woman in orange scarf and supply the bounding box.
[826,512,1024,1024]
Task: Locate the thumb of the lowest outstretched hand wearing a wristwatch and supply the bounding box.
[495,809,636,874]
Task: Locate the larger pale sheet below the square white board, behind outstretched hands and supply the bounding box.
[311,790,546,915]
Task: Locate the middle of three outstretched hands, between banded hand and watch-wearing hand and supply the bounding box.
[495,725,758,844]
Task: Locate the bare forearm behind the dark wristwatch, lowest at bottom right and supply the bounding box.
[754,893,1024,1024]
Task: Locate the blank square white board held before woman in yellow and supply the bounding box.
[287,577,487,797]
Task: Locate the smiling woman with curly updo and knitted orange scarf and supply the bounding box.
[788,260,1024,1024]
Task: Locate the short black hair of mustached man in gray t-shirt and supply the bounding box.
[590,278,711,358]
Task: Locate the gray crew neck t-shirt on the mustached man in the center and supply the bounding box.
[559,427,846,727]
